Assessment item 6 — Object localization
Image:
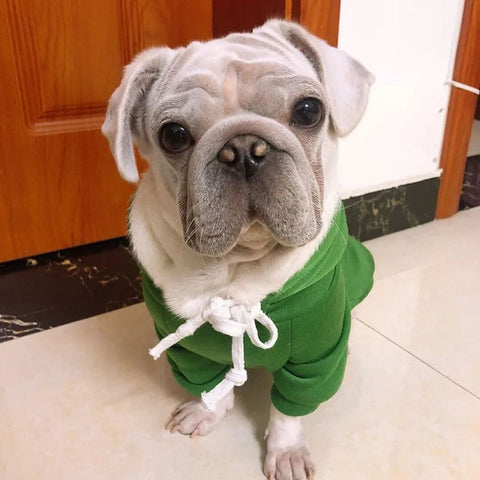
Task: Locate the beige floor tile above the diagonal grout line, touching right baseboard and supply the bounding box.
[355,208,480,397]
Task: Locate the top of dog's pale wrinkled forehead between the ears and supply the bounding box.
[164,33,319,96]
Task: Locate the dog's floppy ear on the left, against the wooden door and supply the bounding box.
[102,48,174,182]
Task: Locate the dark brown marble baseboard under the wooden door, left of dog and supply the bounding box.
[0,238,142,341]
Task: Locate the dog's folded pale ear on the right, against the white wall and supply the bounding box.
[261,20,375,137]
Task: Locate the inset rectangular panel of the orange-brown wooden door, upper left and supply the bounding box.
[6,0,125,135]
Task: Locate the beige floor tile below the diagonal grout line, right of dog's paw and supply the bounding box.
[308,322,480,480]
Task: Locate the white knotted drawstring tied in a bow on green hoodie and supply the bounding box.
[149,297,278,411]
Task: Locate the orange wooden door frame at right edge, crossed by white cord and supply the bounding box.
[436,0,480,218]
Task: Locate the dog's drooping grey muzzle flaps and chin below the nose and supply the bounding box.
[184,157,321,257]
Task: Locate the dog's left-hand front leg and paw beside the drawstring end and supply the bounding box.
[167,391,233,438]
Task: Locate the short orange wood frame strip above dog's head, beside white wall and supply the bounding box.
[300,0,340,47]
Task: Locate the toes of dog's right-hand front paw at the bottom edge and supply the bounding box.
[264,445,315,480]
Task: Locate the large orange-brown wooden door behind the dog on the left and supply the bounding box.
[0,0,212,262]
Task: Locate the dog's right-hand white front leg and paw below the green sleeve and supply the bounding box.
[264,405,315,480]
